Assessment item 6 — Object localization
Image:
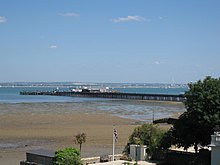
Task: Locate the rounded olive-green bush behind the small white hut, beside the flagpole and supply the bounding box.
[124,124,167,157]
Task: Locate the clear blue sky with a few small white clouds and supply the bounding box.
[0,0,220,83]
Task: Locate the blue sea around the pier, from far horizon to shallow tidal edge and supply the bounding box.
[0,82,188,121]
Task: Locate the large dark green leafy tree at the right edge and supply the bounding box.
[173,77,220,152]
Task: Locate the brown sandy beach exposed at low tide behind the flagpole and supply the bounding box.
[0,103,140,165]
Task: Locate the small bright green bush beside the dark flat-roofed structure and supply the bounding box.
[53,148,82,165]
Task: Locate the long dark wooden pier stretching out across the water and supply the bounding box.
[20,91,184,102]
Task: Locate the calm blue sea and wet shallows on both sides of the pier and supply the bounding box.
[0,86,187,121]
